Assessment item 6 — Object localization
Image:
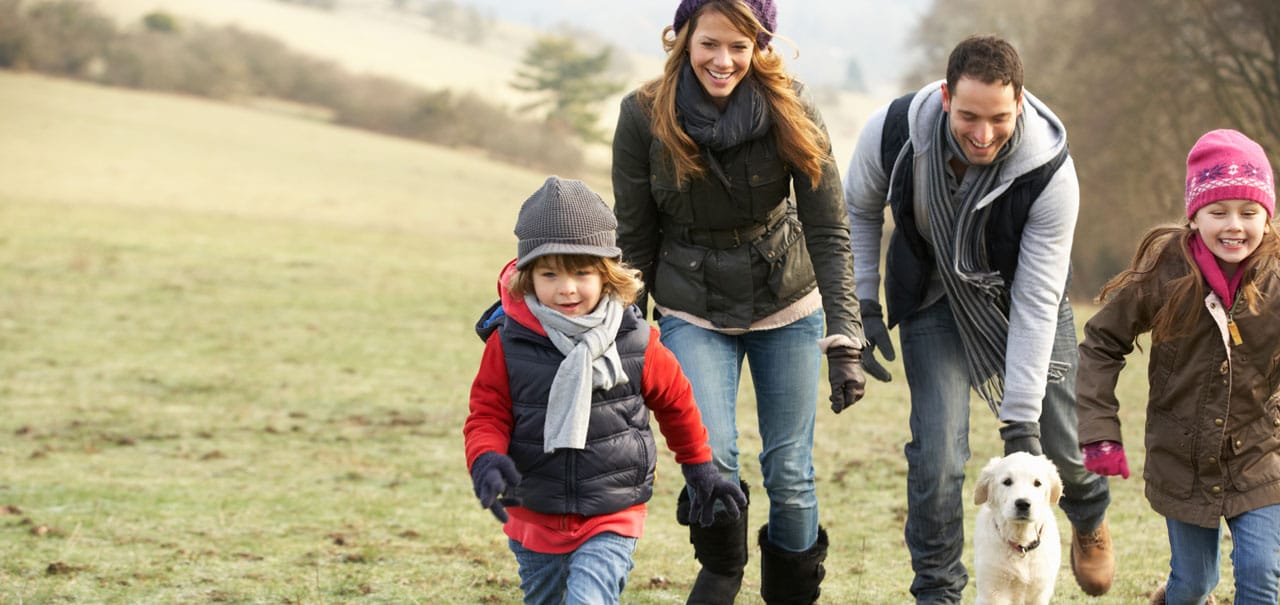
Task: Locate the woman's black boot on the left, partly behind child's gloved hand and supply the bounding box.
[676,482,750,605]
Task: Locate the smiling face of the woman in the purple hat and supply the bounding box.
[689,10,755,109]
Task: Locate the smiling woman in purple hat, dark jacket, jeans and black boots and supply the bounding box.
[613,0,865,602]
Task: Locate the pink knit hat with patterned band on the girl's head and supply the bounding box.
[1187,129,1276,219]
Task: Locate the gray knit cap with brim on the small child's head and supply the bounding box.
[516,177,622,269]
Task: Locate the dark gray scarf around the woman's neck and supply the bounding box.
[676,61,773,189]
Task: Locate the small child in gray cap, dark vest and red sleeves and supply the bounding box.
[462,177,746,604]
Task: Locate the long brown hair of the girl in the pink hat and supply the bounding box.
[1097,223,1280,342]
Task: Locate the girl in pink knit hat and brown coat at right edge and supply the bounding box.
[1076,130,1280,605]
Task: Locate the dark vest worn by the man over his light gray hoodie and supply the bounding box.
[881,92,1068,327]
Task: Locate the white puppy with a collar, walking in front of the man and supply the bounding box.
[973,452,1062,605]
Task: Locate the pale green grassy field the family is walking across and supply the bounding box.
[0,73,1231,604]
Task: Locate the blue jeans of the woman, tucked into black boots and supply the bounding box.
[658,310,823,553]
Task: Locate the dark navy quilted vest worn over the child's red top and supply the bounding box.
[483,306,658,517]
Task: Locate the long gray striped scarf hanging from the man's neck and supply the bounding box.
[924,111,1023,416]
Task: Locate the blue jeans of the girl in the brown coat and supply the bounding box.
[1165,504,1280,605]
